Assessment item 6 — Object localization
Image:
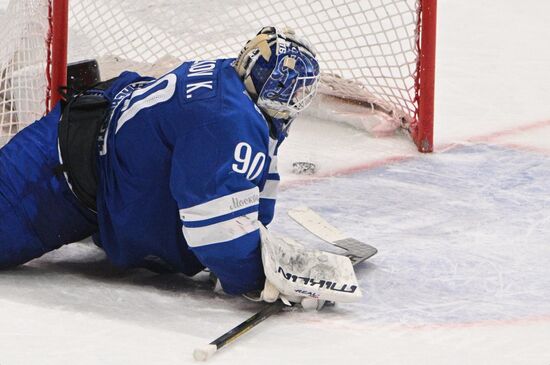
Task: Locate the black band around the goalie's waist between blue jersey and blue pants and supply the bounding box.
[58,80,112,212]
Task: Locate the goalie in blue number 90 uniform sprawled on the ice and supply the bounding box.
[0,27,360,308]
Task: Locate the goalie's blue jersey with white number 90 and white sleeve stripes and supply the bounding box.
[97,59,282,294]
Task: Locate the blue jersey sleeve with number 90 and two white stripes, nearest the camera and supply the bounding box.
[170,118,268,294]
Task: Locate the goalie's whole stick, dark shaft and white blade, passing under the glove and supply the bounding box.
[193,207,378,361]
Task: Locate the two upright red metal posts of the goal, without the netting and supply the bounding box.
[46,0,437,152]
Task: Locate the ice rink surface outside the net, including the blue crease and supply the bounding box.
[0,0,550,365]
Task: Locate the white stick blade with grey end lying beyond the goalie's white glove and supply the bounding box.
[288,207,378,265]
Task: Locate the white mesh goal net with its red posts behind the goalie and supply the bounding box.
[0,0,436,152]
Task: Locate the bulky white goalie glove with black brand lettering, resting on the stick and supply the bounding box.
[247,226,362,309]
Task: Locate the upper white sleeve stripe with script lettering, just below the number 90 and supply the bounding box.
[180,187,260,223]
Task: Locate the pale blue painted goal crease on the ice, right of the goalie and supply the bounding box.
[275,145,550,325]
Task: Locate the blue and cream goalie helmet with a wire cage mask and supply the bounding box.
[235,27,320,121]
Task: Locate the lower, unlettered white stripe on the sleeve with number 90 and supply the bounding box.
[183,212,260,247]
